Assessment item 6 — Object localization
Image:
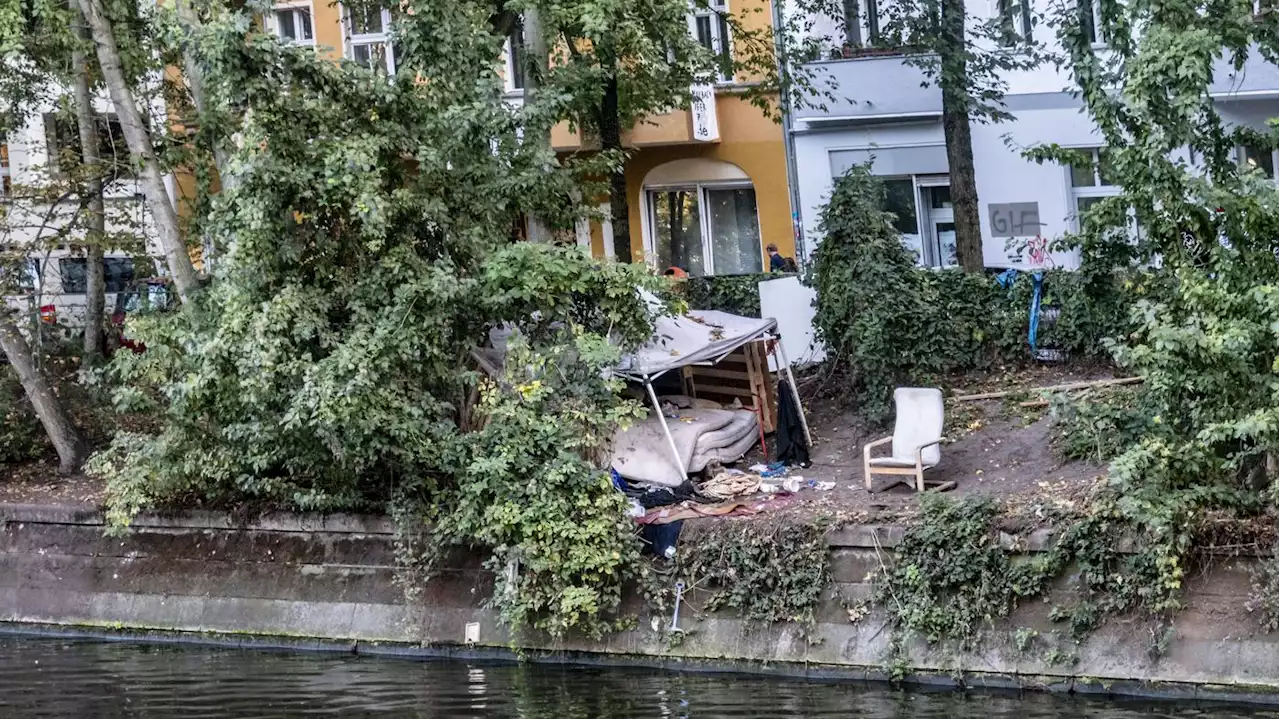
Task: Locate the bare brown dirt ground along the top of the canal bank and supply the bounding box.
[0,366,1111,514]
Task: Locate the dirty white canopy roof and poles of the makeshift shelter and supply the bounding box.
[614,304,813,476]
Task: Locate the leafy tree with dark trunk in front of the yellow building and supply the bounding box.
[519,0,828,261]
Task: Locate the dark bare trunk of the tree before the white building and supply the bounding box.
[938,0,983,273]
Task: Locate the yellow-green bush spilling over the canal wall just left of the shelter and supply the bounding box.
[399,334,643,637]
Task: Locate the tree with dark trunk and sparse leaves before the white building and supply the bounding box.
[880,0,1046,273]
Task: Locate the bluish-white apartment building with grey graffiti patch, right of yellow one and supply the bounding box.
[792,0,1280,269]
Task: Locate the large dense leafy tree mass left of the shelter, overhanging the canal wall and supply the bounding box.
[93,0,653,633]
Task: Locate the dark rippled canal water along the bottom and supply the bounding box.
[0,637,1280,719]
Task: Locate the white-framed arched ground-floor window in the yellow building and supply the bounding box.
[646,186,763,276]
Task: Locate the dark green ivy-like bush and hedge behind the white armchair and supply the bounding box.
[809,166,1152,420]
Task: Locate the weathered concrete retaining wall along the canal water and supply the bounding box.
[0,505,1280,701]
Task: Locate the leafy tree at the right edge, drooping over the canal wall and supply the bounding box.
[1029,0,1280,598]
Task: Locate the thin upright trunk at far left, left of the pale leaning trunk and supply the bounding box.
[69,0,106,362]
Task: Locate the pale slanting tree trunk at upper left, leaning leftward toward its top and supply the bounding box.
[77,0,200,303]
